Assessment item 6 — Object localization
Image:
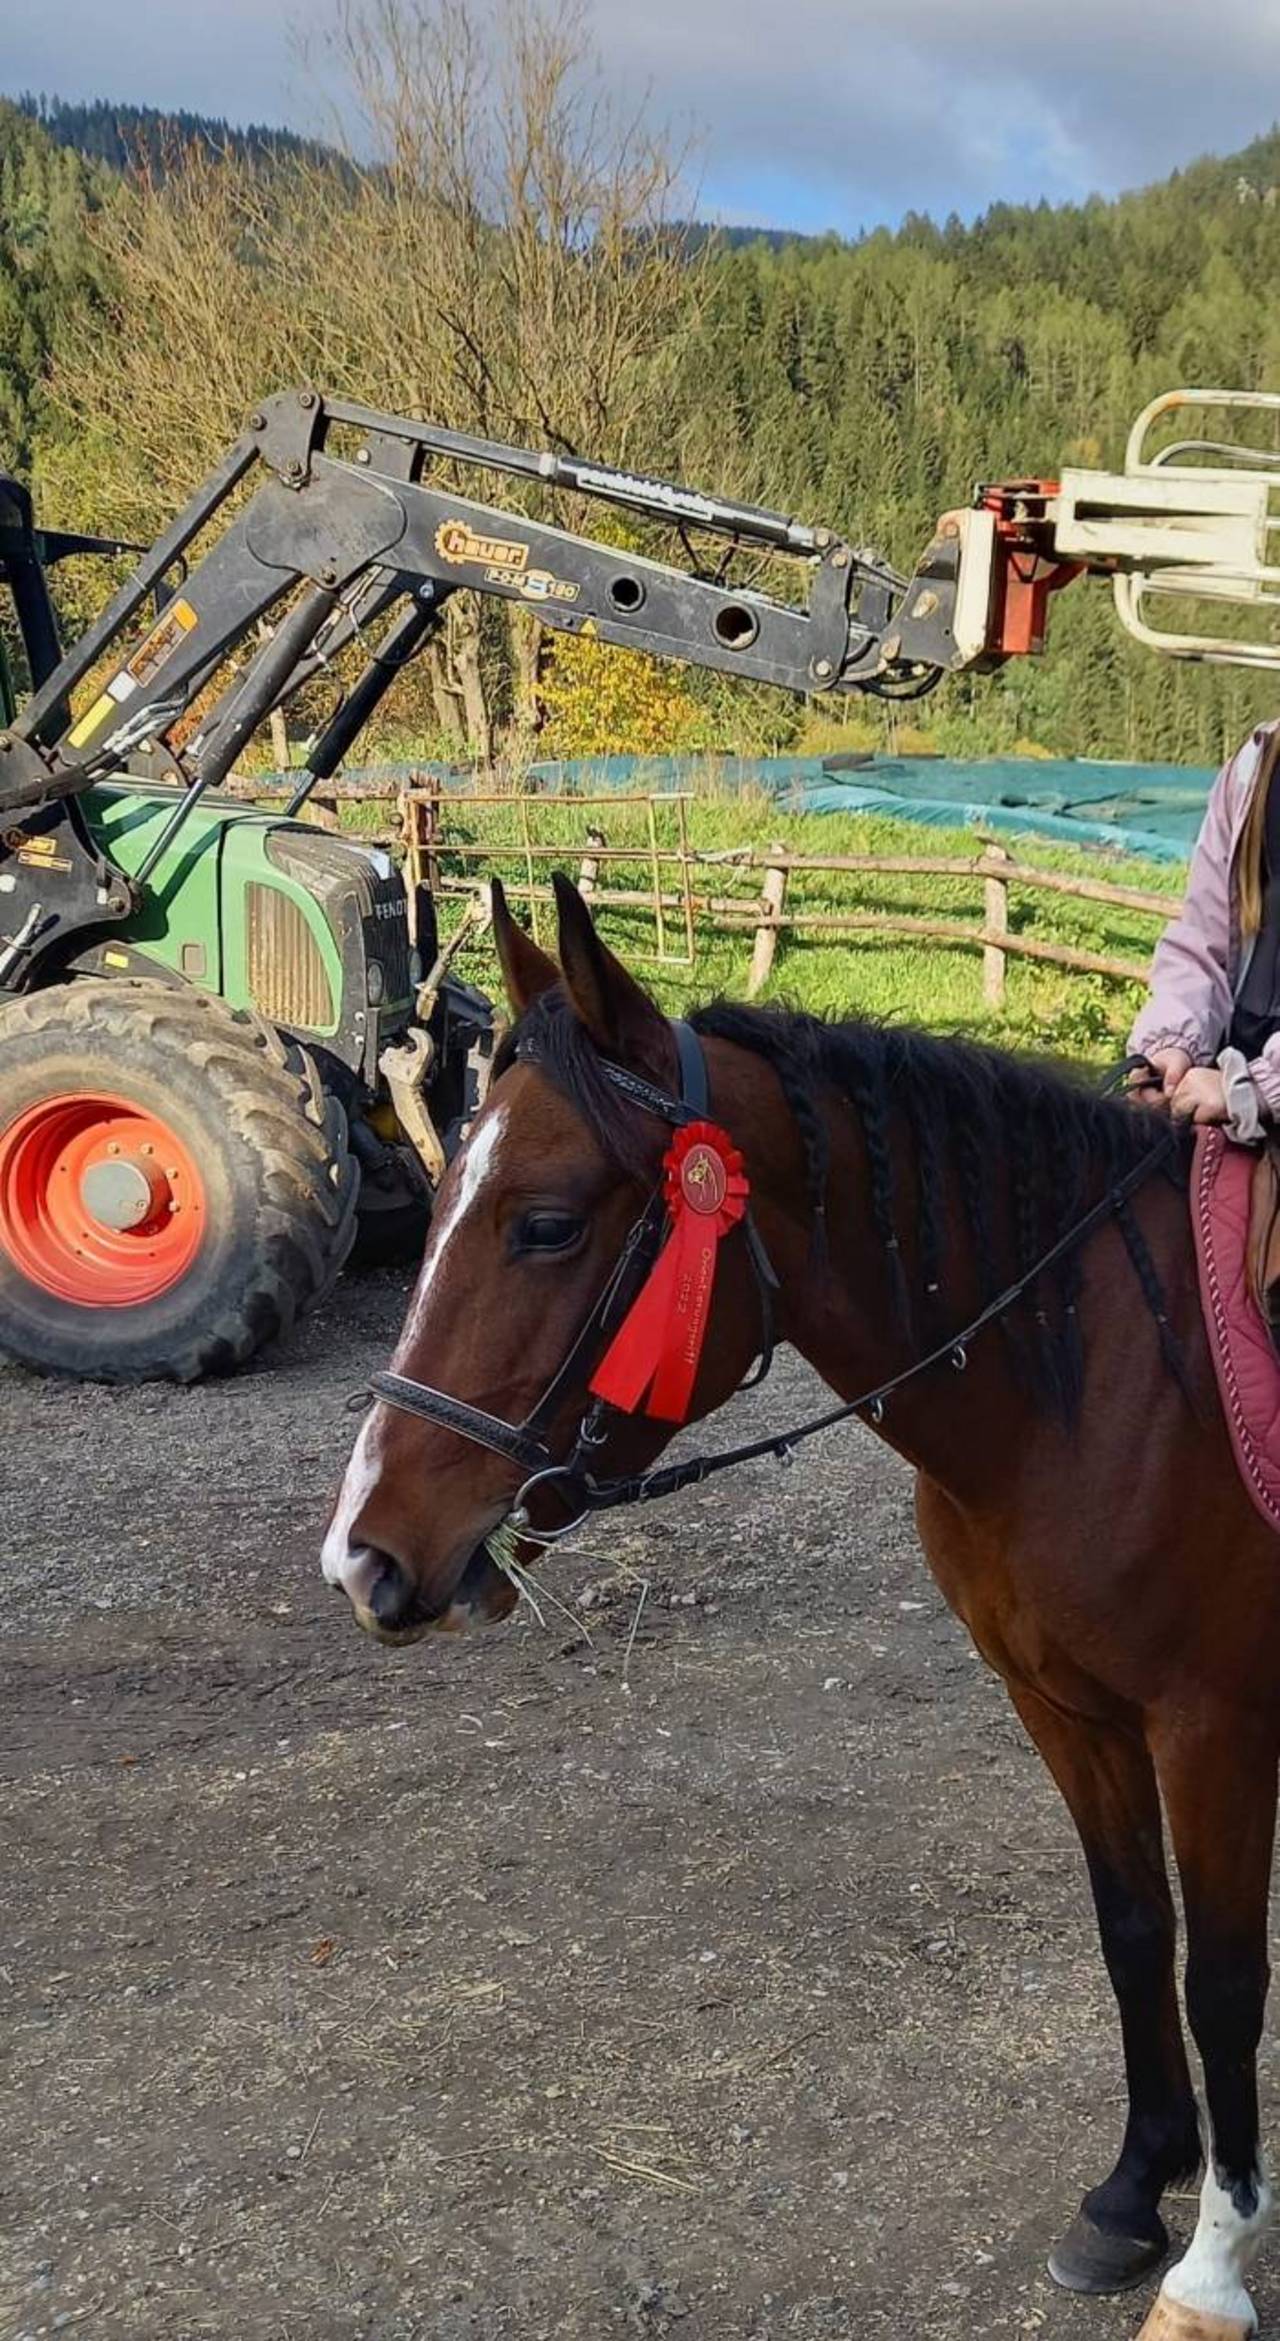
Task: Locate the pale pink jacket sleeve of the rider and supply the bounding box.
[1128,742,1244,1067]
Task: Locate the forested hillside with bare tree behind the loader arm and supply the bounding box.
[0,25,1280,763]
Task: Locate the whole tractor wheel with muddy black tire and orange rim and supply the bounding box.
[0,979,360,1381]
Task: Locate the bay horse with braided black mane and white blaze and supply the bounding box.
[323,878,1280,2341]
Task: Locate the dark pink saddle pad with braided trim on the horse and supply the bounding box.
[1191,1131,1280,1529]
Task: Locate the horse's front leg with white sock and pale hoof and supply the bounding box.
[1144,1709,1278,2341]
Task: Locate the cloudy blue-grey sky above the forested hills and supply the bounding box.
[0,0,1280,234]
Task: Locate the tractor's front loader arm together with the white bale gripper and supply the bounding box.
[10,374,1280,833]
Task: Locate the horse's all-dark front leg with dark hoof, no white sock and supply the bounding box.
[1006,1681,1200,2292]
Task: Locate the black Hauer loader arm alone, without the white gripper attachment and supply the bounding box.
[0,391,959,812]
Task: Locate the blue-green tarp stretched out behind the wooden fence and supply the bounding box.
[332,756,1214,861]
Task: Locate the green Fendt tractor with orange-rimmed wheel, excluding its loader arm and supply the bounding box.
[0,456,491,1381]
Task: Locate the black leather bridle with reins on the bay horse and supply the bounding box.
[370,1021,1177,1543]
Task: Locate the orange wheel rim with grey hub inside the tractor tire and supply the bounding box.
[0,1091,206,1309]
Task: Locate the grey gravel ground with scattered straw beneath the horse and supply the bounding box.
[0,1276,1280,2341]
